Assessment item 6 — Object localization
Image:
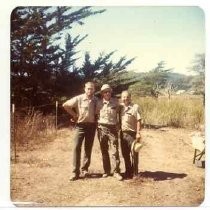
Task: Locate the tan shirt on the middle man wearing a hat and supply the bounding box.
[96,98,119,125]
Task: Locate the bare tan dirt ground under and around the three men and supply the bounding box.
[11,128,205,206]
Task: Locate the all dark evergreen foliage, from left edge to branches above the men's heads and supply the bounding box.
[11,7,134,106]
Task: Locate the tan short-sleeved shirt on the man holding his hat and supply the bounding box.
[120,103,141,132]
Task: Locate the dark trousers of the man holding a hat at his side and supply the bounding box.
[120,131,139,175]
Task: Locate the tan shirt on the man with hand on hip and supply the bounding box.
[63,94,97,123]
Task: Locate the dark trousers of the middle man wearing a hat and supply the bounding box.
[98,126,120,174]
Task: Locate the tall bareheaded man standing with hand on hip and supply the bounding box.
[63,82,97,181]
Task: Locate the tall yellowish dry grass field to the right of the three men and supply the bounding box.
[133,96,204,129]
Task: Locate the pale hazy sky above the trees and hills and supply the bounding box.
[65,6,205,75]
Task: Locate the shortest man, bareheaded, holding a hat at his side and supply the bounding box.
[120,91,141,178]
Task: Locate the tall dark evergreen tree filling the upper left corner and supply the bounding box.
[11,7,104,105]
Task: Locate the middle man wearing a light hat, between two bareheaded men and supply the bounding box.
[96,84,122,181]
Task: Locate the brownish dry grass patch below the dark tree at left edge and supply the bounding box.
[11,110,56,149]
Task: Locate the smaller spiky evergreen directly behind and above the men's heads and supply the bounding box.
[79,51,135,94]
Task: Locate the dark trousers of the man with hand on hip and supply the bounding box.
[72,123,96,174]
